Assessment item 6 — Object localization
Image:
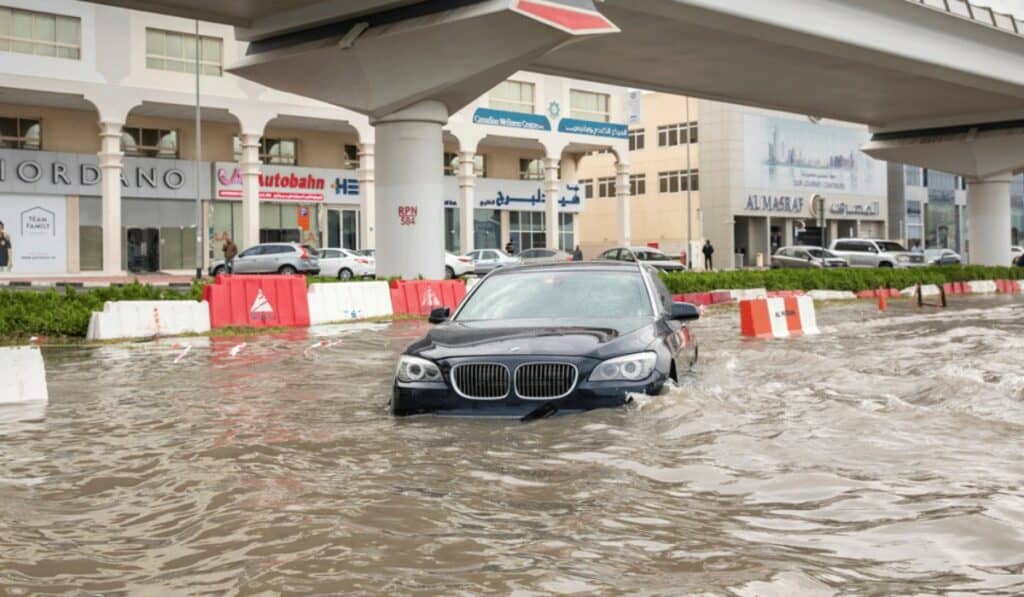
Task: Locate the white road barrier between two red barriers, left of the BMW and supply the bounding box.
[309,282,393,325]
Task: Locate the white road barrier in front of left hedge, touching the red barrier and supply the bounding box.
[86,301,210,340]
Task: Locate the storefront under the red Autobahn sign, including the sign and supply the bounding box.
[210,162,361,258]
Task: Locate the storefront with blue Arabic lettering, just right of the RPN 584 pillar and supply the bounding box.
[444,176,583,253]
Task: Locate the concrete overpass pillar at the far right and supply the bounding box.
[967,174,1011,266]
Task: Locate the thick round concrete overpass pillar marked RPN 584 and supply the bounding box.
[371,100,449,280]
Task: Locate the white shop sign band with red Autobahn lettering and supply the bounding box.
[214,162,359,204]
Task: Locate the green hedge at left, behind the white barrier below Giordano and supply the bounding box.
[0,282,203,338]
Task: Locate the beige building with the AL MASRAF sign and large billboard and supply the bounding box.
[579,93,888,269]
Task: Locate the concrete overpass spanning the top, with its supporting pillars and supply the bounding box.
[90,0,1024,276]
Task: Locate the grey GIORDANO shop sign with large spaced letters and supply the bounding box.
[0,150,211,200]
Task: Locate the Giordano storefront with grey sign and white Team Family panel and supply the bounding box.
[0,150,210,273]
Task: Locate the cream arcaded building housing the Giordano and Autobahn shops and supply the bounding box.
[0,0,627,273]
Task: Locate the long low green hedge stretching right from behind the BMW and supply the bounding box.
[662,265,1024,294]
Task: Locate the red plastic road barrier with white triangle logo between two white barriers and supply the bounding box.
[203,275,309,329]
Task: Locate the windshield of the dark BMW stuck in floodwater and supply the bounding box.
[457,270,653,322]
